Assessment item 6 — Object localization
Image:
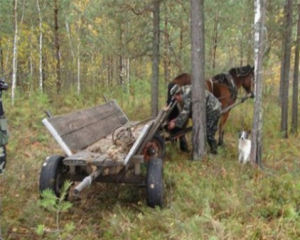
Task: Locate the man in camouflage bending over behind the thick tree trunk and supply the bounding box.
[168,85,221,154]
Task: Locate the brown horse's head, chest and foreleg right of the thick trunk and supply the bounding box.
[206,65,254,146]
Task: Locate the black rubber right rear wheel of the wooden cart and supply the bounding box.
[146,158,163,208]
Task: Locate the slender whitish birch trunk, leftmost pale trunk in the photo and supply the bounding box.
[11,0,18,105]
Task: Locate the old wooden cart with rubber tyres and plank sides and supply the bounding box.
[39,98,174,207]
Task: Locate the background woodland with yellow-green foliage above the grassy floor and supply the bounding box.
[0,0,284,94]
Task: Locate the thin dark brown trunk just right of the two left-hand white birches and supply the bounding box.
[54,0,61,94]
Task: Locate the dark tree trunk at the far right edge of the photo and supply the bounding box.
[291,3,300,133]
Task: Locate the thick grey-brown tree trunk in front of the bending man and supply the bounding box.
[191,0,206,160]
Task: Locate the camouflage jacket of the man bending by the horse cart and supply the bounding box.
[175,85,221,128]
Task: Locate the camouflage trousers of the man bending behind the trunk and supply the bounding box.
[206,109,221,144]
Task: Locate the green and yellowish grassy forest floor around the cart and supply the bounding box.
[0,87,300,240]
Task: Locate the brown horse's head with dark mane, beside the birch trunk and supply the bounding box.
[229,65,254,98]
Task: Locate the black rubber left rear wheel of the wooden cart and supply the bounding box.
[40,155,69,198]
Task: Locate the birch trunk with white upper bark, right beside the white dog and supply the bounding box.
[250,0,266,165]
